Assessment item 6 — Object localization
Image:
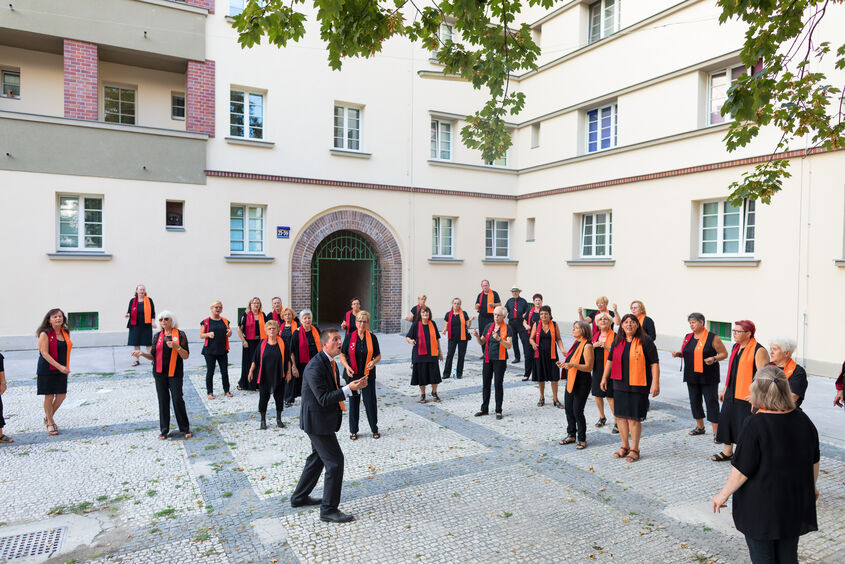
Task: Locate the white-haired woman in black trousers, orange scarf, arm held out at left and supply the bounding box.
[132,310,193,441]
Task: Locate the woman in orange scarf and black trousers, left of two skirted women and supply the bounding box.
[558,321,594,450]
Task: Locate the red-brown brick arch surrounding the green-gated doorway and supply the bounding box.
[290,210,402,333]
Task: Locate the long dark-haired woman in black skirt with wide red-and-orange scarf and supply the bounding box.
[601,313,660,462]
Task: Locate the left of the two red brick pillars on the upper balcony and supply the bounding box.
[64,39,99,121]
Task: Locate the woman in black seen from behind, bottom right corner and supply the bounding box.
[713,365,819,564]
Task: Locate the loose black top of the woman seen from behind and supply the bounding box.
[731,409,819,540]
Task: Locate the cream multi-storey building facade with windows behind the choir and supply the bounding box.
[0,0,845,374]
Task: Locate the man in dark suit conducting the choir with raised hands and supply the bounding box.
[290,329,367,523]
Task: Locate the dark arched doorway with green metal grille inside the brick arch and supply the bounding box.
[311,230,381,327]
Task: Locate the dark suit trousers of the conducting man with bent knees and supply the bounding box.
[291,433,343,514]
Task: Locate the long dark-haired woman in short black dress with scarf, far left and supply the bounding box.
[36,308,73,435]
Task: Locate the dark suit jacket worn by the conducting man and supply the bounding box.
[299,351,346,435]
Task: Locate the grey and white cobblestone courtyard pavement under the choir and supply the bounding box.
[0,350,845,564]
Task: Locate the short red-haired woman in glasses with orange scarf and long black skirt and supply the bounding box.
[710,319,769,462]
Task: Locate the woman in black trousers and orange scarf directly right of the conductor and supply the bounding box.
[340,310,381,441]
